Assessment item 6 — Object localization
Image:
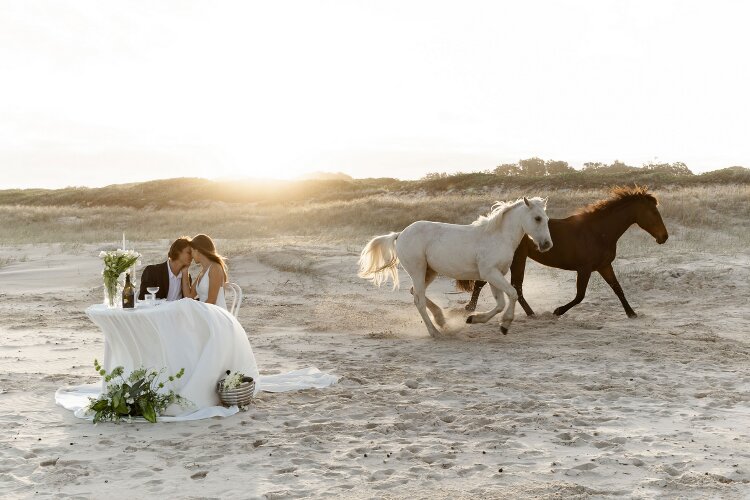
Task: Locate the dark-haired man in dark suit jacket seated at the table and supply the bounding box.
[138,236,193,300]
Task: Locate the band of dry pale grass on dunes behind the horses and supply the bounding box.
[0,185,750,258]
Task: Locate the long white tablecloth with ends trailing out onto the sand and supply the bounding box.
[55,299,338,421]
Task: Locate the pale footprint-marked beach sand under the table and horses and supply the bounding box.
[0,242,750,498]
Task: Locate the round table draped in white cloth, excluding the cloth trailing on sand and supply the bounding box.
[86,299,259,416]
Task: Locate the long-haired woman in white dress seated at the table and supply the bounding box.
[182,234,228,309]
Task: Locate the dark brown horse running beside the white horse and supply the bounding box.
[464,186,669,318]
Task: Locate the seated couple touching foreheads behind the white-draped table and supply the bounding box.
[138,234,228,309]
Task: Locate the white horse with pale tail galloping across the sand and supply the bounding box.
[359,198,552,337]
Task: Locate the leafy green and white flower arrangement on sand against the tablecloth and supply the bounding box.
[87,360,187,424]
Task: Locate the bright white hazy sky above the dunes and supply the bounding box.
[0,0,750,189]
